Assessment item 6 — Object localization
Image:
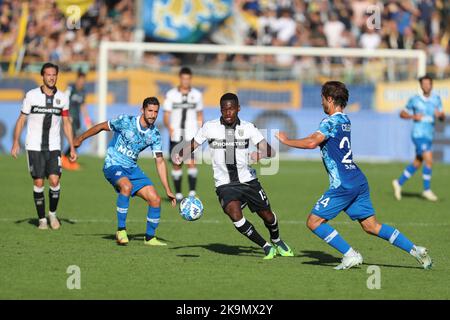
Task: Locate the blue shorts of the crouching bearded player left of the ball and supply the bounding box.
[103,166,153,197]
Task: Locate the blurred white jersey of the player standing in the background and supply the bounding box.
[163,88,203,142]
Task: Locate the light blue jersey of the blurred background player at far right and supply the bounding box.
[406,93,442,140]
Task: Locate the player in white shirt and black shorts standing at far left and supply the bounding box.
[11,62,77,229]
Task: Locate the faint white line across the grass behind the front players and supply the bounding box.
[0,218,450,227]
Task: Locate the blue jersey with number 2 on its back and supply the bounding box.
[318,112,367,189]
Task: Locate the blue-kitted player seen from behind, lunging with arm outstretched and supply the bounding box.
[276,81,432,270]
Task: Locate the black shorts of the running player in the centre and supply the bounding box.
[216,179,271,212]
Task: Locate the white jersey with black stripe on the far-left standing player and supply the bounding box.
[21,87,69,151]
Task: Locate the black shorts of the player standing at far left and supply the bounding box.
[27,150,62,179]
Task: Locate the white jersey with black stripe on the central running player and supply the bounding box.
[194,118,264,187]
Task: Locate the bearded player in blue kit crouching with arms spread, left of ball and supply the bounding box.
[74,97,176,246]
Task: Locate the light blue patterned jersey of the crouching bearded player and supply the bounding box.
[104,115,162,168]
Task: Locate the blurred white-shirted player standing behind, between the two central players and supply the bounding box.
[163,67,203,201]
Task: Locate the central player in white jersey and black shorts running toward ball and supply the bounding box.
[173,93,294,259]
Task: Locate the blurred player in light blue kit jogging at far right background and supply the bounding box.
[392,76,445,201]
